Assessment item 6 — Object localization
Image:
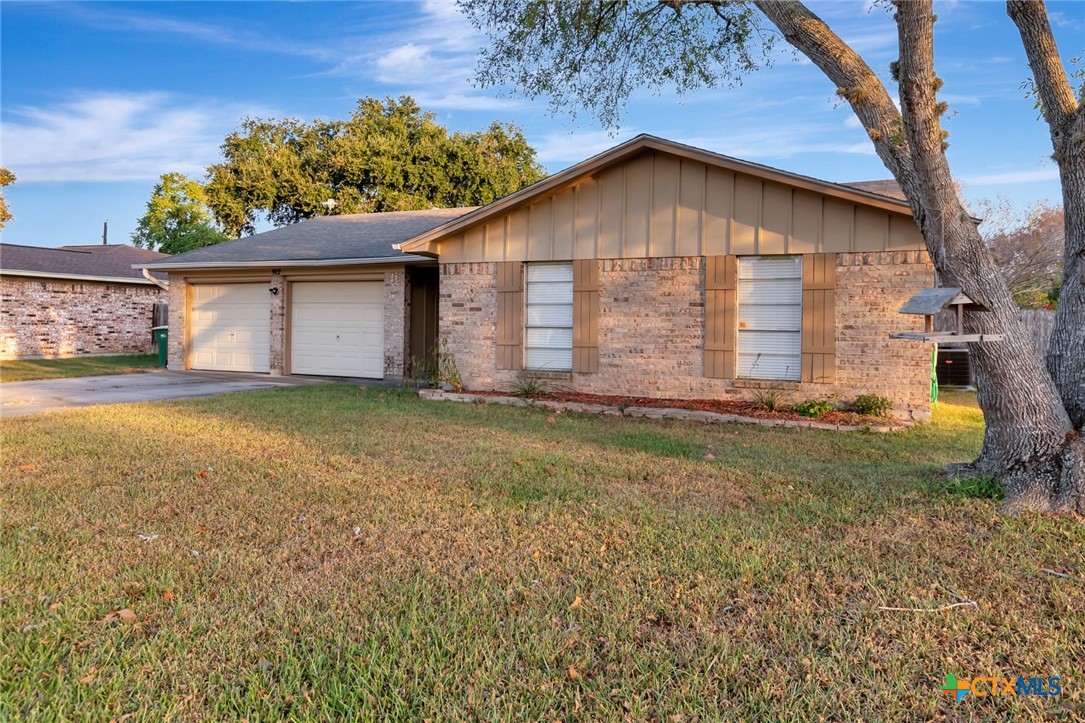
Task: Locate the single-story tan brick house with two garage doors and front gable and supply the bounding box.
[149,136,933,418]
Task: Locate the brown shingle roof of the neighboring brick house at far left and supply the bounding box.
[0,243,169,283]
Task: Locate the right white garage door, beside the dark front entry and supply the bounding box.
[290,281,384,379]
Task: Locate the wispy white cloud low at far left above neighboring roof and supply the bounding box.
[2,92,269,183]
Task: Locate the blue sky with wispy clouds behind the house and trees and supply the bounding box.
[0,0,1085,246]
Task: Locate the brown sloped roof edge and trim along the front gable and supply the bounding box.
[400,134,911,253]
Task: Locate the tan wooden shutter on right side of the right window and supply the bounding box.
[802,254,837,384]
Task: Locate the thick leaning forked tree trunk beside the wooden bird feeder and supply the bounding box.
[755,0,1085,511]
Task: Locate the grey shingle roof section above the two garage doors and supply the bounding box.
[138,206,475,269]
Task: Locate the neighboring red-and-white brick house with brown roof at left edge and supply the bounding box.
[0,243,168,359]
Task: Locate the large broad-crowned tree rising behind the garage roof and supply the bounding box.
[207,97,545,233]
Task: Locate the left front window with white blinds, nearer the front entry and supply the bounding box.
[524,263,573,371]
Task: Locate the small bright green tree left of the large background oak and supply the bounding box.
[131,174,230,254]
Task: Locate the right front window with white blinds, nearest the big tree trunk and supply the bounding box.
[738,256,803,381]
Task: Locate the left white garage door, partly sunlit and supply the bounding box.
[189,283,271,371]
